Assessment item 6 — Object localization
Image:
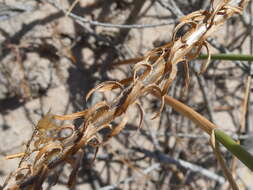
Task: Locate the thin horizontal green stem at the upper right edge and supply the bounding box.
[197,54,253,61]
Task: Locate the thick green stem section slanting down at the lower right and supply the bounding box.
[214,129,253,171]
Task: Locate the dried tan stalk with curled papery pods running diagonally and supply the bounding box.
[4,0,248,189]
